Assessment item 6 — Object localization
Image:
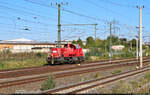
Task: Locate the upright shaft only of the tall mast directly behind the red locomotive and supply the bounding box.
[57,4,61,48]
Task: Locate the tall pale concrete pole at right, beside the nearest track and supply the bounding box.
[137,6,144,68]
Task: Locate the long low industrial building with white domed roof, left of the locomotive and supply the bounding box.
[0,38,56,53]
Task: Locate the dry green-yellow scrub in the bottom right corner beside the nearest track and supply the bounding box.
[100,73,150,93]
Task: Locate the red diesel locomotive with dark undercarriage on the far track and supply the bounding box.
[47,44,85,64]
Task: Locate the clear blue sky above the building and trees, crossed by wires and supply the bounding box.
[0,0,150,42]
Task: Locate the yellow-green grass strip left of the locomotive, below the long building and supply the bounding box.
[0,51,47,70]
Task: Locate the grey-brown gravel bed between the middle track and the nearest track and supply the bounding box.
[0,63,135,93]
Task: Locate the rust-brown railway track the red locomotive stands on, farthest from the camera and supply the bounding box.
[0,58,148,79]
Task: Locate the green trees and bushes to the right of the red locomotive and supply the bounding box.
[72,35,150,61]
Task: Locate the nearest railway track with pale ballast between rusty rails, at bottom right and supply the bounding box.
[42,67,150,94]
